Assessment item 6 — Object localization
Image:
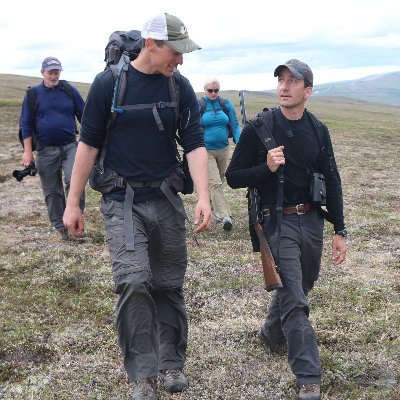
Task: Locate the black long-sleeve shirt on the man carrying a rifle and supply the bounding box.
[225,109,344,231]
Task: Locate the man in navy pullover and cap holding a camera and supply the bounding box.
[21,57,85,240]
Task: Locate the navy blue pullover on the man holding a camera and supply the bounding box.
[21,82,84,146]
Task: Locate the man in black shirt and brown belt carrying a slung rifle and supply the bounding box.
[226,59,346,400]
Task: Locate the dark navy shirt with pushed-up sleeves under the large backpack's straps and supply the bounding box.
[80,65,204,201]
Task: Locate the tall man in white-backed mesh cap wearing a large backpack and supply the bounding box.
[64,14,211,400]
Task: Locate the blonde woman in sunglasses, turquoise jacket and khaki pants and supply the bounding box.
[199,78,240,230]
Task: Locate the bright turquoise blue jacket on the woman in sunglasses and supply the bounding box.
[199,96,240,150]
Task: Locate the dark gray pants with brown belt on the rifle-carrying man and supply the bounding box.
[262,210,324,385]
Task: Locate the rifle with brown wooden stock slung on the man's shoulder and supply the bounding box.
[239,90,283,292]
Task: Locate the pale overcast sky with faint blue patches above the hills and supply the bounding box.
[0,0,400,91]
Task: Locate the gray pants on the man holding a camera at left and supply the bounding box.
[36,142,85,231]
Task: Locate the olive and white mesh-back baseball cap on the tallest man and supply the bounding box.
[142,13,201,53]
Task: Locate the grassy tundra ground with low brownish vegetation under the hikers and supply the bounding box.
[0,77,400,400]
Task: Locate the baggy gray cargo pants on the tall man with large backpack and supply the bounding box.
[101,196,188,381]
